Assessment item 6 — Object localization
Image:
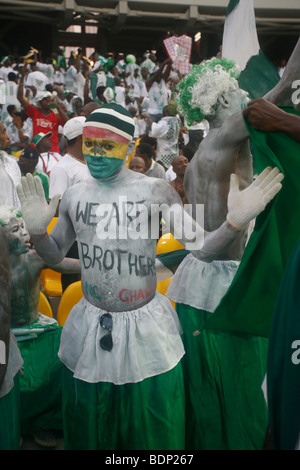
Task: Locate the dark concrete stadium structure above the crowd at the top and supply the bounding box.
[0,0,300,62]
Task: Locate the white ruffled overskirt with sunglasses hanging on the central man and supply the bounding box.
[58,292,184,385]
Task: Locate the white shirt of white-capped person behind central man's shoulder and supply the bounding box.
[49,153,92,199]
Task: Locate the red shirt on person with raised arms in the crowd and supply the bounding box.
[25,103,63,153]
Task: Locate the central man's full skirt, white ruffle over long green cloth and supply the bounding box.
[59,292,185,450]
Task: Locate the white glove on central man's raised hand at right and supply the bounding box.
[227,167,284,230]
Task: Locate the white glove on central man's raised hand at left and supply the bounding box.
[17,173,60,235]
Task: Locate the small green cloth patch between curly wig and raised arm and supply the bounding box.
[238,51,280,99]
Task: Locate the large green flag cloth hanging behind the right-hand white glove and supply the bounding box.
[205,108,300,337]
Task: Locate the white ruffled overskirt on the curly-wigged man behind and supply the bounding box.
[167,253,240,313]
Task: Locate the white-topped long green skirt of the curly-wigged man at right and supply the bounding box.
[167,254,268,450]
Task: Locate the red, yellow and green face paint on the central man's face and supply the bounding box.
[82,128,128,179]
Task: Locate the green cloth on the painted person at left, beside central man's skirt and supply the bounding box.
[18,323,62,435]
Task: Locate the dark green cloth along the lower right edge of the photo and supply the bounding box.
[267,240,300,450]
